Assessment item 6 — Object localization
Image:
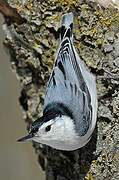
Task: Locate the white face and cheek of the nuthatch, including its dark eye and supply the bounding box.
[33,116,76,149]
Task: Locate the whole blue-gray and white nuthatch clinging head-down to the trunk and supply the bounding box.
[18,12,98,151]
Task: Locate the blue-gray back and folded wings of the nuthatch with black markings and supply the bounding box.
[44,13,92,136]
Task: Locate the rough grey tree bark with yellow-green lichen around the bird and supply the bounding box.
[0,0,119,180]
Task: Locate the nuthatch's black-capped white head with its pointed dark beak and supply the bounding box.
[18,103,76,149]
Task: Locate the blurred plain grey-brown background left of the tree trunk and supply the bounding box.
[0,15,45,180]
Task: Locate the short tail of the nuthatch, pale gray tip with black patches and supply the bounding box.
[60,12,73,41]
